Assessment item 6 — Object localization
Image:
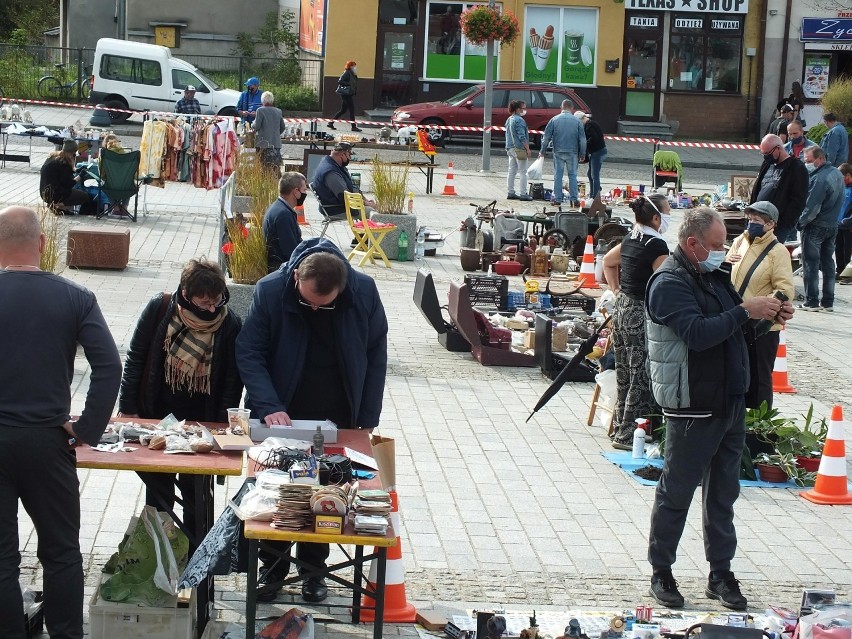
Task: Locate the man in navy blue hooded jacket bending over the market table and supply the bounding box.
[237,238,388,602]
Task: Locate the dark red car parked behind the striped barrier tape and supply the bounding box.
[392,82,590,145]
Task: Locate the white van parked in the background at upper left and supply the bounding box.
[89,38,240,122]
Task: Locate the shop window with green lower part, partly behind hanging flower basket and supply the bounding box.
[423,0,499,80]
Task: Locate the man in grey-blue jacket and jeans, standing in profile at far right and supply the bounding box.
[796,146,846,312]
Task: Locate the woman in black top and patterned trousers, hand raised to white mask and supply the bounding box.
[604,193,671,450]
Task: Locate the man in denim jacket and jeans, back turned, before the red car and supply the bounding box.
[539,100,586,206]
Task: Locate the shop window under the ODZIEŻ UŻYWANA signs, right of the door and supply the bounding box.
[669,14,743,93]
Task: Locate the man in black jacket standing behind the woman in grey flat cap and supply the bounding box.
[749,134,808,244]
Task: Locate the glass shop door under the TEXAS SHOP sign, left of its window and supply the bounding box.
[621,12,663,121]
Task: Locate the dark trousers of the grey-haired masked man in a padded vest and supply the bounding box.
[648,396,745,570]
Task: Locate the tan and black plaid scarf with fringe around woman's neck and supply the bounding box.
[164,304,228,395]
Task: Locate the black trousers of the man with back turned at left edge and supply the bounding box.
[0,426,83,639]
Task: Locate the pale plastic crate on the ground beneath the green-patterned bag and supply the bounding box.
[89,575,197,639]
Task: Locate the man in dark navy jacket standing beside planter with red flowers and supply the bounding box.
[263,171,308,273]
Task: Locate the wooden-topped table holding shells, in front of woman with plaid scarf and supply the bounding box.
[75,418,243,637]
